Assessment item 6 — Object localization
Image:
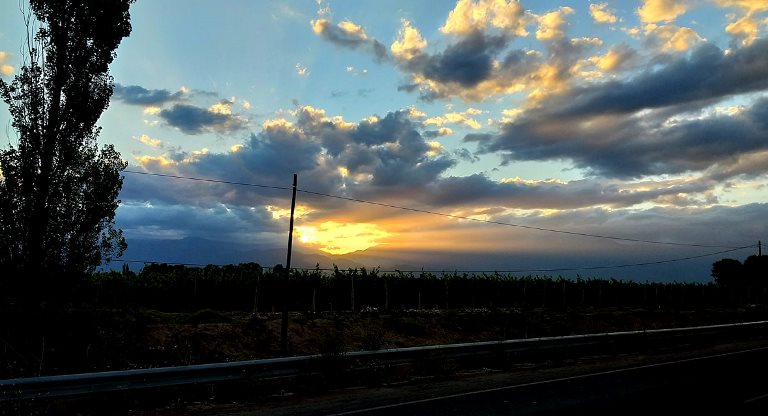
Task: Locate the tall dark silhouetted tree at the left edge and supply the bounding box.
[0,0,134,287]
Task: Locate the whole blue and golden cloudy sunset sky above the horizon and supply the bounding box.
[0,0,768,282]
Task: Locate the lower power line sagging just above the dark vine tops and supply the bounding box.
[105,245,754,274]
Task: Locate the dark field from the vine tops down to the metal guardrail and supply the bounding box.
[0,265,768,378]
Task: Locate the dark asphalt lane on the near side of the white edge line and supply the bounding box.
[328,348,768,416]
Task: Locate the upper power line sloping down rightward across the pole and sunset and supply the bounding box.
[123,170,743,250]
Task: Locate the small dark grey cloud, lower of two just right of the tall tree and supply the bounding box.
[158,104,246,135]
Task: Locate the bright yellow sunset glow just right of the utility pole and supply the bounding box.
[296,221,392,255]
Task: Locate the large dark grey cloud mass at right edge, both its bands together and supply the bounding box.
[472,42,768,178]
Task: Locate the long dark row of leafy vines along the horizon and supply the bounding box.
[77,263,768,312]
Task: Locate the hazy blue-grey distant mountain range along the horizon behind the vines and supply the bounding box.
[112,238,719,282]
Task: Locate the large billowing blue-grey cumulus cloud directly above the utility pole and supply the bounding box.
[126,106,456,210]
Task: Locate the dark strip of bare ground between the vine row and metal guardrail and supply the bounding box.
[0,306,768,378]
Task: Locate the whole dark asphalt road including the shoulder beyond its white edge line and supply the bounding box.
[214,344,768,416]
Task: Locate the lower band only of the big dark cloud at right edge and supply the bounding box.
[464,91,768,178]
